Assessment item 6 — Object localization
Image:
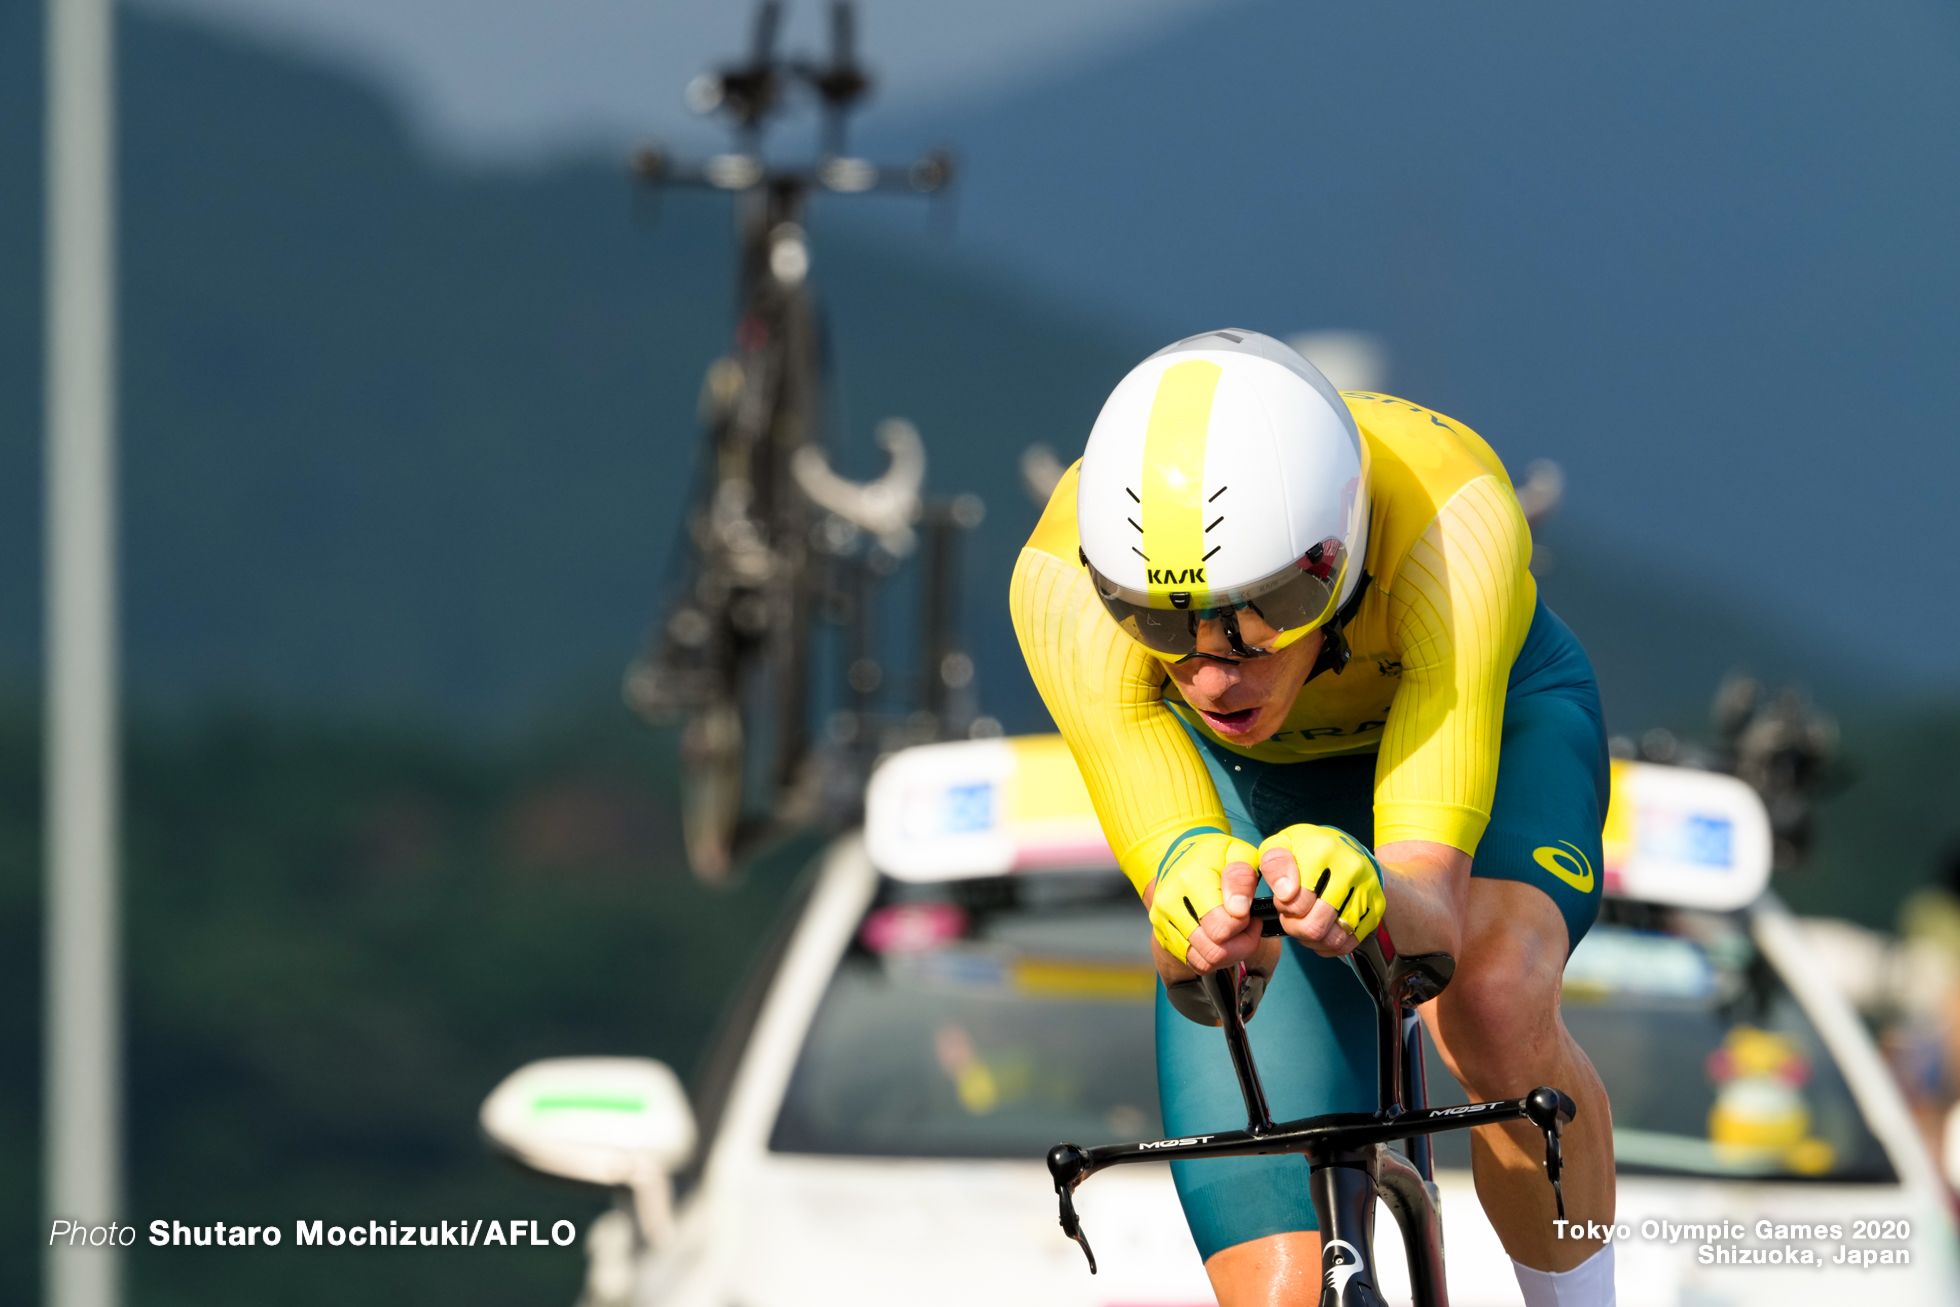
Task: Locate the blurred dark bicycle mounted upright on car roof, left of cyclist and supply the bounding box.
[625,0,980,882]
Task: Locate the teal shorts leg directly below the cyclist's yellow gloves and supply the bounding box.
[1156,941,1376,1260]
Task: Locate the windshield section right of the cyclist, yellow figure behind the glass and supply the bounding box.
[1429,899,1893,1184]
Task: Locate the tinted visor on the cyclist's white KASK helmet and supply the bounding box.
[1088,539,1348,658]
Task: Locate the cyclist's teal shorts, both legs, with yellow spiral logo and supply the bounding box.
[1156,604,1607,1260]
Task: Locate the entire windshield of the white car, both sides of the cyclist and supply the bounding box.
[770,874,1893,1184]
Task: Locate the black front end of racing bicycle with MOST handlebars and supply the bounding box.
[1049,899,1578,1307]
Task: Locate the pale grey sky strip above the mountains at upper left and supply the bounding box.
[141,0,1231,161]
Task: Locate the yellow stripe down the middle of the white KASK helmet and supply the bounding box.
[1139,359,1223,607]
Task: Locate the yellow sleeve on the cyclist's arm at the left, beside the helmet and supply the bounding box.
[1007,468,1231,894]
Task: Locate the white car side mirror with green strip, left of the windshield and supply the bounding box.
[478,1058,696,1246]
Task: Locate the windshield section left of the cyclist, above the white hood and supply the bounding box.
[770,874,1162,1158]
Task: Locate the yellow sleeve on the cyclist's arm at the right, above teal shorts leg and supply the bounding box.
[1374,476,1539,854]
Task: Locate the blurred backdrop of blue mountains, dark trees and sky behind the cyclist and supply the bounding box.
[11,0,1960,1303]
